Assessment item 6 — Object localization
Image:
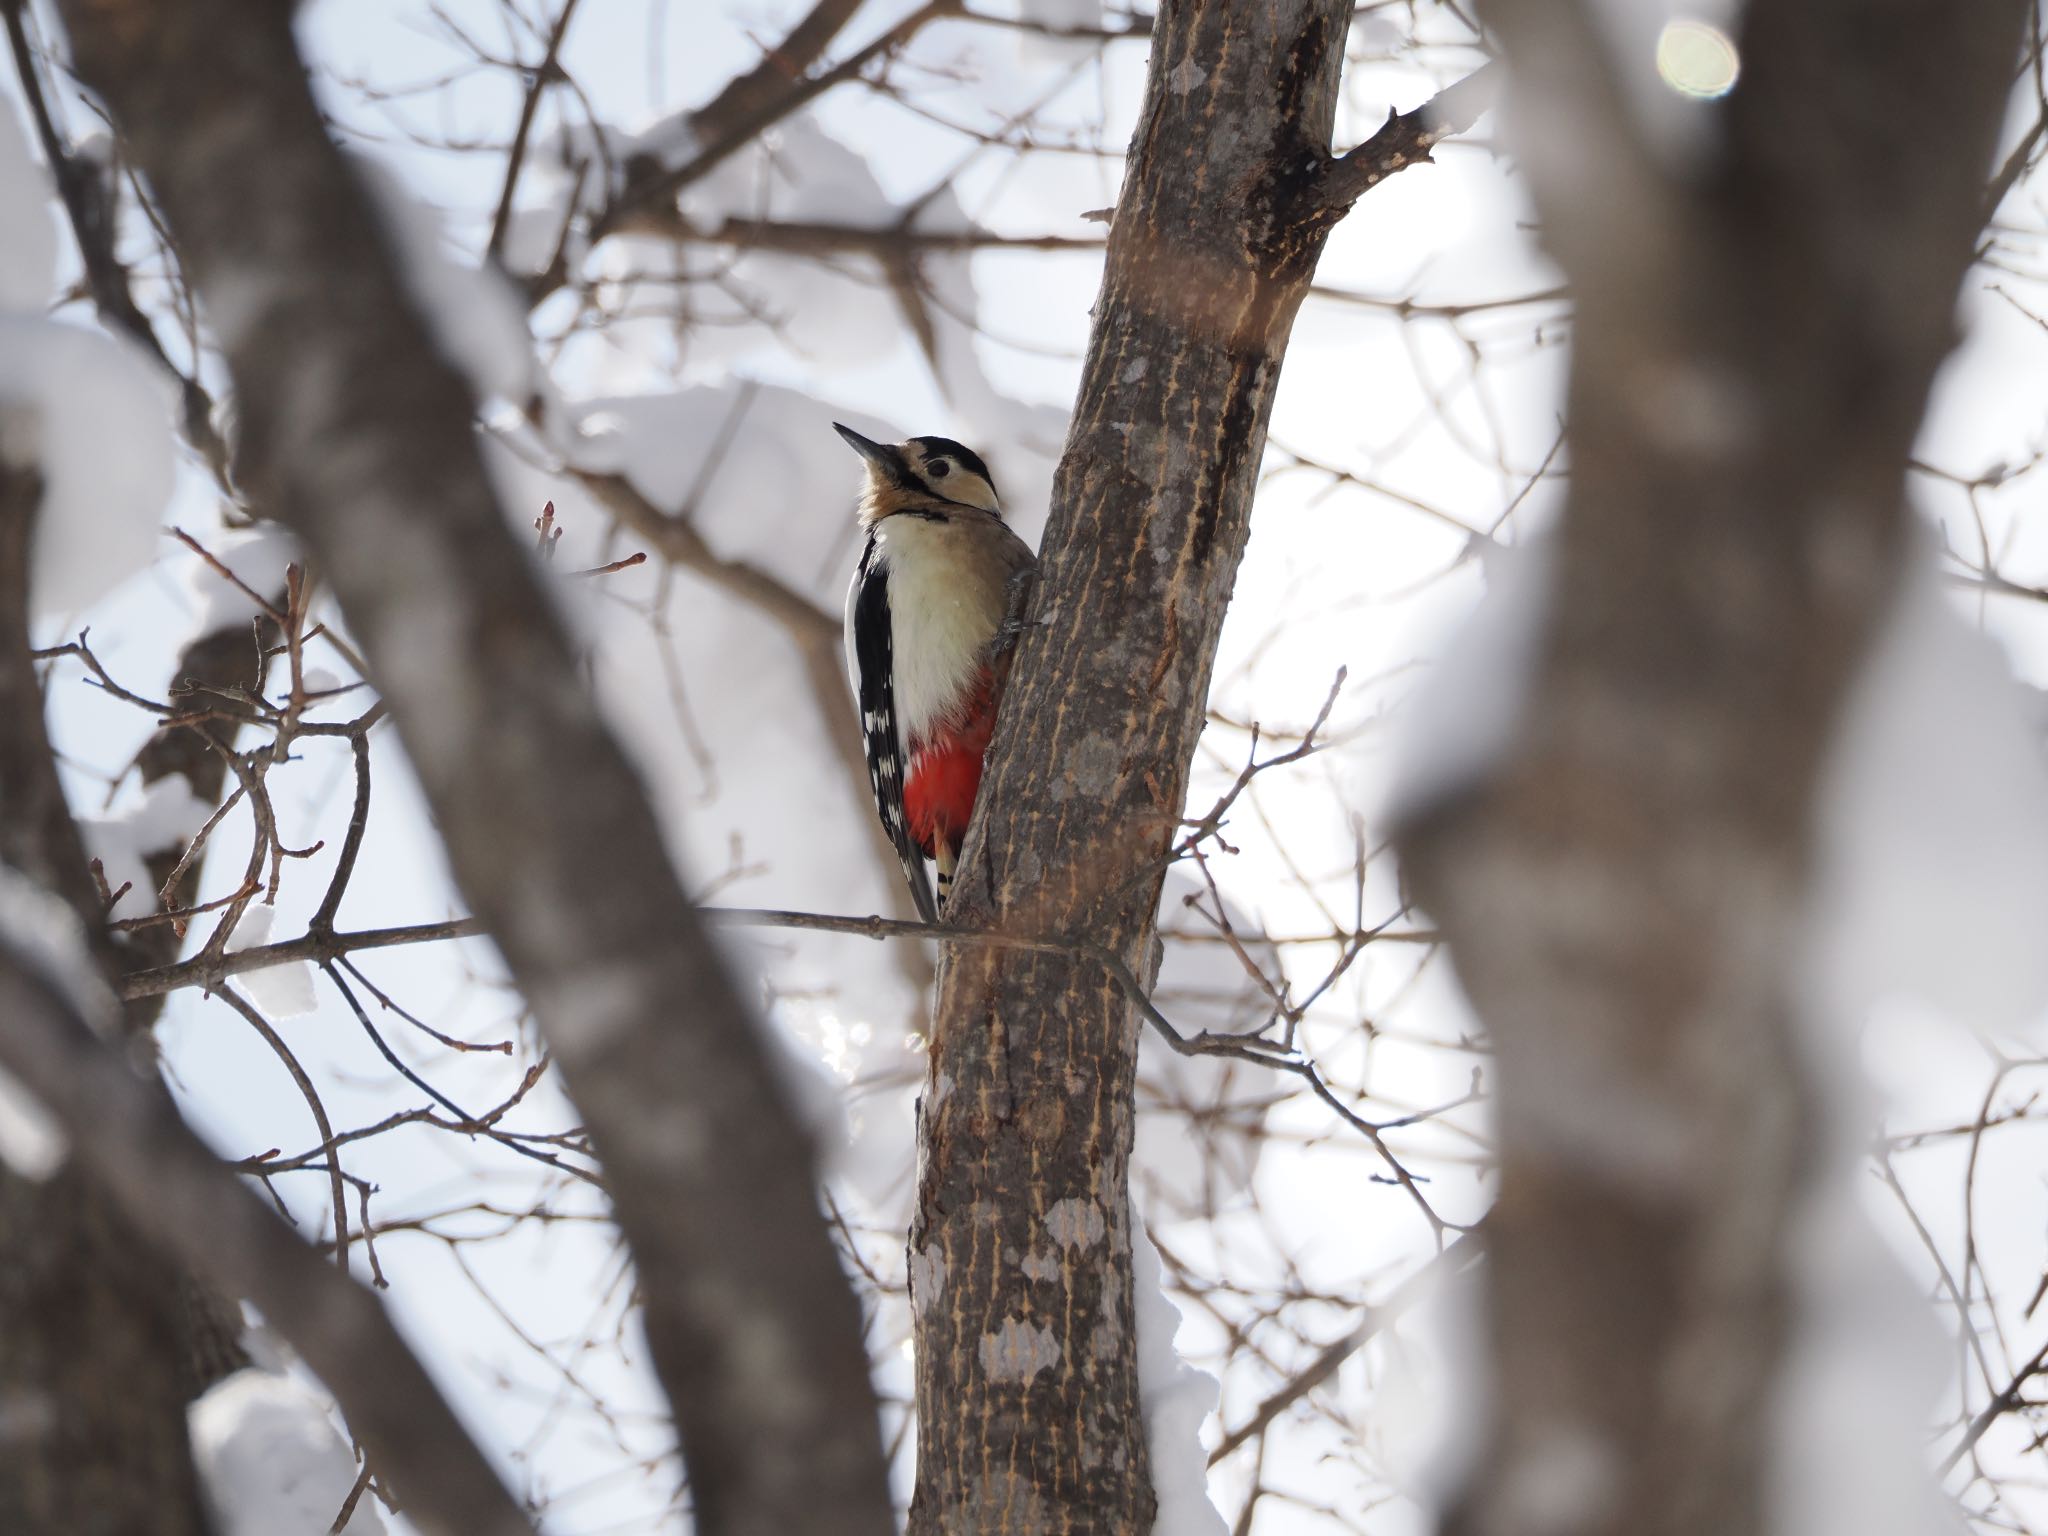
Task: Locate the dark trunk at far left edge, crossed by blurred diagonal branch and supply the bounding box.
[0,461,205,1536]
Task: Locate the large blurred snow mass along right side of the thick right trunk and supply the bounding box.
[1767,549,2048,1536]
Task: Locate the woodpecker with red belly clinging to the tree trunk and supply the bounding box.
[834,422,1038,922]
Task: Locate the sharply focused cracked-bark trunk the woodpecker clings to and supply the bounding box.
[909,0,1350,1536]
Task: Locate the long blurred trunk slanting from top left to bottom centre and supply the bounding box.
[61,0,891,1536]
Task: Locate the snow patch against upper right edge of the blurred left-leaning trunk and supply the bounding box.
[356,158,539,406]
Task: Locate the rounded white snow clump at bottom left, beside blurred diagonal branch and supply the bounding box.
[188,1368,385,1536]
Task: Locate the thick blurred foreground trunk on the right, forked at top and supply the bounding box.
[1401,0,2021,1536]
